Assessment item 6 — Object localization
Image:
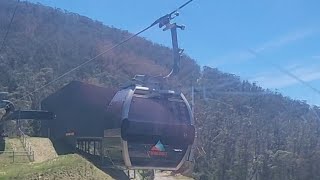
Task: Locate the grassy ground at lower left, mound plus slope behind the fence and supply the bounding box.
[0,138,113,180]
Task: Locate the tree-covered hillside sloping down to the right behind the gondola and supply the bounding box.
[0,0,320,180]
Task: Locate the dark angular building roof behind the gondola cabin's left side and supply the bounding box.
[41,81,117,137]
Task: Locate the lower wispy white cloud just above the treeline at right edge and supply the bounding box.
[250,64,320,88]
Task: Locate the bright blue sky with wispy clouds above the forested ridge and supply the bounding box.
[25,0,320,105]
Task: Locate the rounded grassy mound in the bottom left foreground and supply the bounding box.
[0,155,113,179]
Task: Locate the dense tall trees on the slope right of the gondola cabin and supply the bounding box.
[191,68,320,180]
